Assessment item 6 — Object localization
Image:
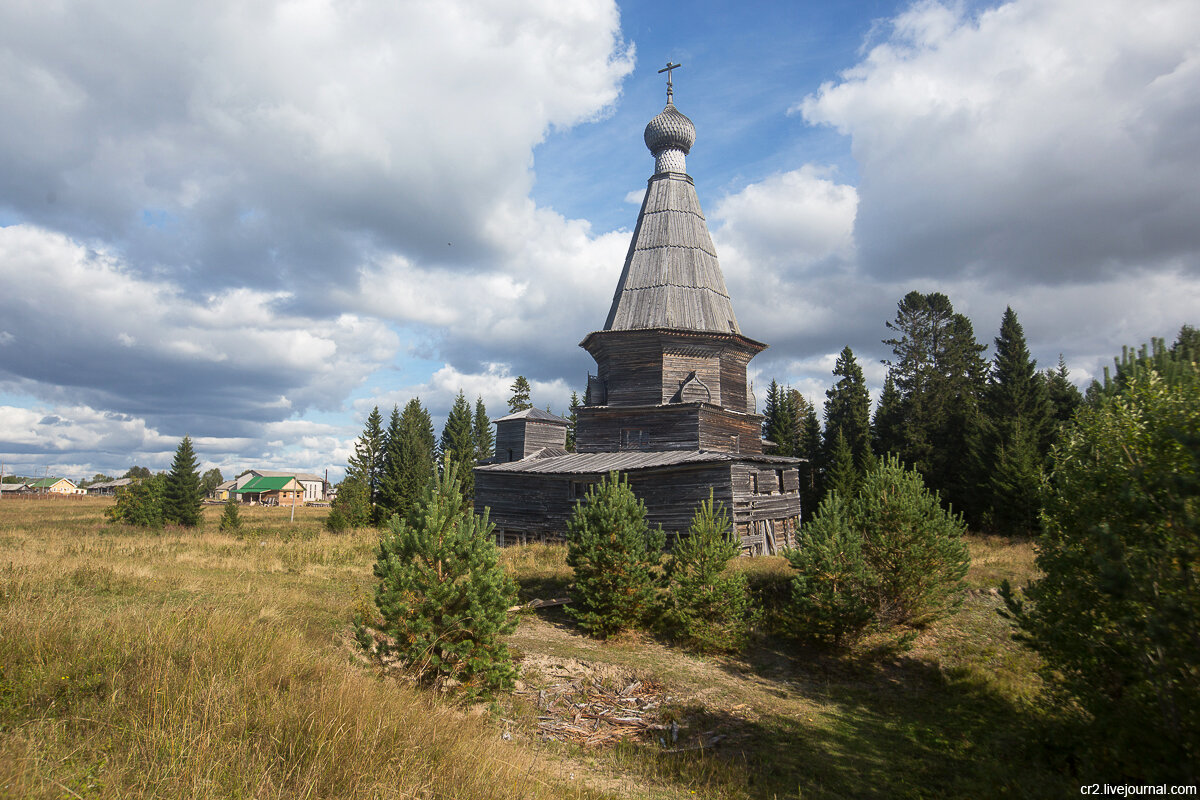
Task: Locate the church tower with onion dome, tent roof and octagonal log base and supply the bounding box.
[575,64,767,452]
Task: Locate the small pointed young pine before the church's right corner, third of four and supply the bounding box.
[662,491,750,652]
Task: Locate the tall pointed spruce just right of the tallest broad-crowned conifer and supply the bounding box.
[980,307,1051,534]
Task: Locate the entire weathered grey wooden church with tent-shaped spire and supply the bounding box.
[475,70,800,554]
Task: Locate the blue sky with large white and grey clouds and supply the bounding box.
[0,0,1200,477]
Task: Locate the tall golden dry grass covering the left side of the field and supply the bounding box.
[0,500,609,798]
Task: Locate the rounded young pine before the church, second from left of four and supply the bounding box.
[566,473,666,638]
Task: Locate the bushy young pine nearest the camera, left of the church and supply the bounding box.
[374,467,516,696]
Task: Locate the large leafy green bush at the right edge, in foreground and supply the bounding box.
[1002,342,1200,783]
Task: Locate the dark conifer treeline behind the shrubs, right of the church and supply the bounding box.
[763,291,1200,534]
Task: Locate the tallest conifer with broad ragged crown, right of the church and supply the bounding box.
[883,291,988,509]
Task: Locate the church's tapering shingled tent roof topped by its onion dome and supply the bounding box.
[604,65,740,333]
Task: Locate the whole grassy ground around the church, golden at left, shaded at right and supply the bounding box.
[0,498,1078,800]
